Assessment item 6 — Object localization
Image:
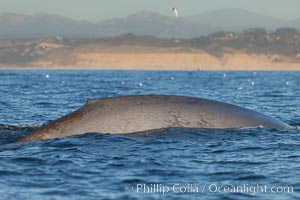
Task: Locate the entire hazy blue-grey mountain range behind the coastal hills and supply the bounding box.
[0,9,300,39]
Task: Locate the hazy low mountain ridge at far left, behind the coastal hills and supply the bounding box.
[0,13,96,38]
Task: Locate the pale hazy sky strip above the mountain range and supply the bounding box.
[0,0,300,22]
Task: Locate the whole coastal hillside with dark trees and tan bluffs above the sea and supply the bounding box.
[0,28,300,70]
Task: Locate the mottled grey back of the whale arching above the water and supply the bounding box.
[19,95,290,142]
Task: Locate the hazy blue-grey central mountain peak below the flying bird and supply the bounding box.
[98,10,215,37]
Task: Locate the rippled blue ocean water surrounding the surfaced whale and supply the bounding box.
[0,70,300,200]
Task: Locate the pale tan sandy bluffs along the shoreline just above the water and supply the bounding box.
[0,52,300,71]
